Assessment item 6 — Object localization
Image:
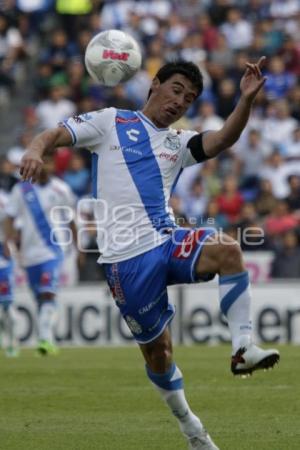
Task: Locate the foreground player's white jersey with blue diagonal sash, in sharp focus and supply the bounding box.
[64,108,197,263]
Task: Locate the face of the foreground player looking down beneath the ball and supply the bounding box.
[150,74,198,127]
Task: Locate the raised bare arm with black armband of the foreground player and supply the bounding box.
[188,56,266,162]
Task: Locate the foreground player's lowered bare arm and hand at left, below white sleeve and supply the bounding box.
[20,127,72,183]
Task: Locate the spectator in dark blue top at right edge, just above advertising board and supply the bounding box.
[270,229,300,280]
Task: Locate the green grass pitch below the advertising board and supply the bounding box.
[0,346,300,450]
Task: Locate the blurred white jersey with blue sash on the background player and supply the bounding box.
[6,177,75,267]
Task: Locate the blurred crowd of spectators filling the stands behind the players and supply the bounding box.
[0,0,300,278]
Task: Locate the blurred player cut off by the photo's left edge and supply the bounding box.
[0,189,19,356]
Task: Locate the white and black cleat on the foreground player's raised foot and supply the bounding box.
[231,339,280,375]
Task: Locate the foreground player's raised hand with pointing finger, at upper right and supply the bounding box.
[240,56,267,101]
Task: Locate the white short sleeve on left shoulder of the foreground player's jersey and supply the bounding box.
[60,108,116,148]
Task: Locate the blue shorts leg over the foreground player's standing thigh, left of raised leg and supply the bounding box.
[104,246,175,344]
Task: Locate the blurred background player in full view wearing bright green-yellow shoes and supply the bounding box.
[5,159,76,355]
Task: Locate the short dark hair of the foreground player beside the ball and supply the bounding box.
[148,60,203,98]
